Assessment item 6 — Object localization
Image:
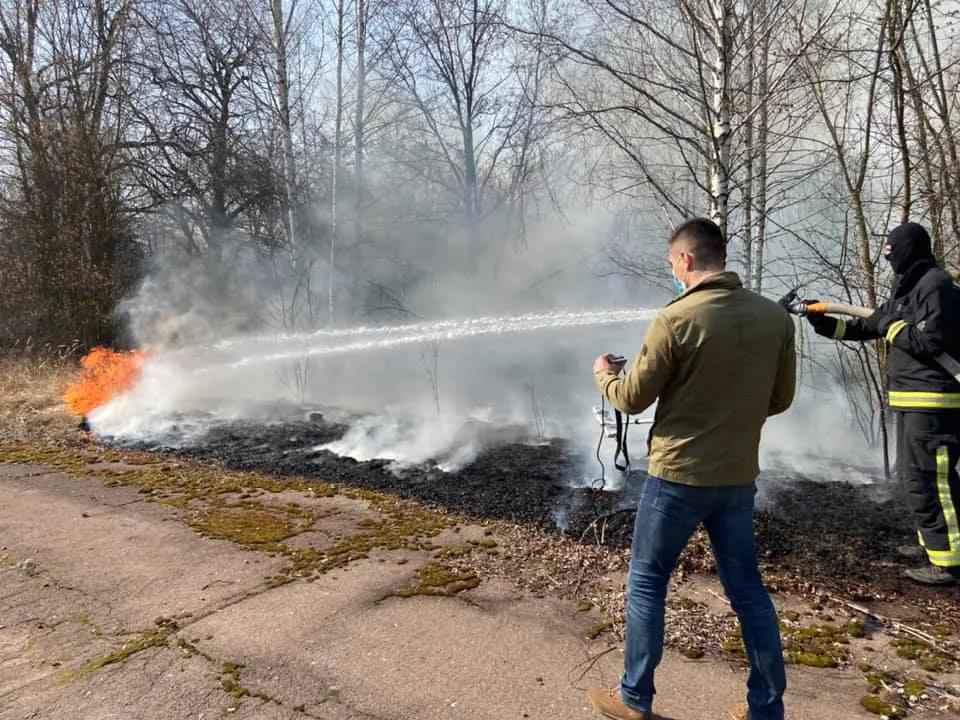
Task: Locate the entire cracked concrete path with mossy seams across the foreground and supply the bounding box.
[0,465,921,720]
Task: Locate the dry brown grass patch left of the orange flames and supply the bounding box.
[0,352,81,445]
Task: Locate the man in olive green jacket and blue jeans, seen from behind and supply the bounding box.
[590,218,796,720]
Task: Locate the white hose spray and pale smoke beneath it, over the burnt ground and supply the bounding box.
[90,308,656,471]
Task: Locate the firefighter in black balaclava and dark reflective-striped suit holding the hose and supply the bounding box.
[808,223,960,585]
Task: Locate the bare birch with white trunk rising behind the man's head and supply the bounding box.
[538,0,835,272]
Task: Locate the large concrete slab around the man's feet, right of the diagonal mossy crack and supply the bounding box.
[169,561,864,720]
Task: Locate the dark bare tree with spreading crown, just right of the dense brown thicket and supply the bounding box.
[131,0,274,258]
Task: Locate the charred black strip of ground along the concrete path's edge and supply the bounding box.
[103,416,944,595]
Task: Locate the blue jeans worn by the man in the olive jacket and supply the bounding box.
[620,477,787,720]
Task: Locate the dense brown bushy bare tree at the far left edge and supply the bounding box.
[0,0,135,344]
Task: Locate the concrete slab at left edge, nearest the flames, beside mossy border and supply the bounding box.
[0,466,284,629]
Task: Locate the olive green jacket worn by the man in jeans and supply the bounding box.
[596,272,796,486]
